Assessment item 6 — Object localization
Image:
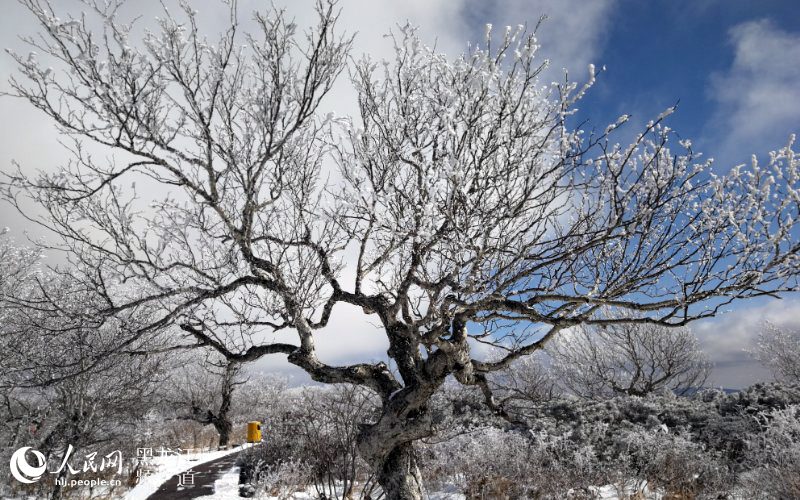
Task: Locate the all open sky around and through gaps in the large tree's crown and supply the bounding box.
[0,0,800,387]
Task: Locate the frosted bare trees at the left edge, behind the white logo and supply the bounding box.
[0,241,163,499]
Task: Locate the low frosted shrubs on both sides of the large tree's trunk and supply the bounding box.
[227,378,800,499]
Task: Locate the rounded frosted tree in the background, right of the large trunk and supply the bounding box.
[547,323,711,398]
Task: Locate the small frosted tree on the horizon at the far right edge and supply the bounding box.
[754,323,800,384]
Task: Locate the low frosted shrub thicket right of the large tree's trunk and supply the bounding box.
[421,384,800,498]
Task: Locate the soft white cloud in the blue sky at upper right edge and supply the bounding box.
[705,20,800,162]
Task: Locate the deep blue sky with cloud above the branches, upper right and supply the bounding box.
[463,0,800,168]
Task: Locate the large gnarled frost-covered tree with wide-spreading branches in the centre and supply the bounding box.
[4,0,800,499]
